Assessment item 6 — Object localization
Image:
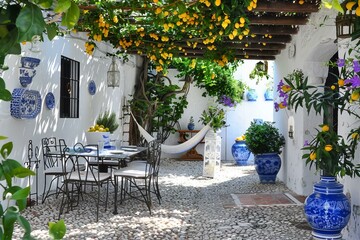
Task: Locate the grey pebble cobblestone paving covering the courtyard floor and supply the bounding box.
[14,159,311,240]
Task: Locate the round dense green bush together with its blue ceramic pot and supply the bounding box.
[245,121,285,183]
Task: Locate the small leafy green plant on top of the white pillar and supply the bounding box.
[199,106,226,132]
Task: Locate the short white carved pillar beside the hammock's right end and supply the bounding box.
[203,129,221,178]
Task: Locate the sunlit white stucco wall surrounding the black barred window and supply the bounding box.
[0,33,136,193]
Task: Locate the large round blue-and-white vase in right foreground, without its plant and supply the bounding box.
[304,176,351,239]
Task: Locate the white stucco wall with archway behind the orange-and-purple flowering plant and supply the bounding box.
[274,9,360,239]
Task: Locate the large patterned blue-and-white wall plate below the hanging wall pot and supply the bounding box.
[10,88,41,119]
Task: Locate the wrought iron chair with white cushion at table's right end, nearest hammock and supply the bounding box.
[113,141,161,214]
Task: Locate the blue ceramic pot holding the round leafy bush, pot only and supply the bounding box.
[254,153,281,183]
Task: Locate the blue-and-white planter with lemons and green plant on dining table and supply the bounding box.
[85,110,119,147]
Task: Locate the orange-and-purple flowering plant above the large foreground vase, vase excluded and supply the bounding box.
[275,66,360,177]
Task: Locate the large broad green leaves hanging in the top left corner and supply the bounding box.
[0,0,80,64]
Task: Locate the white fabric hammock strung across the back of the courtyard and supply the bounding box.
[131,113,210,154]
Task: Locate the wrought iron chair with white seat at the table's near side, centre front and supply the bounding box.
[59,143,111,221]
